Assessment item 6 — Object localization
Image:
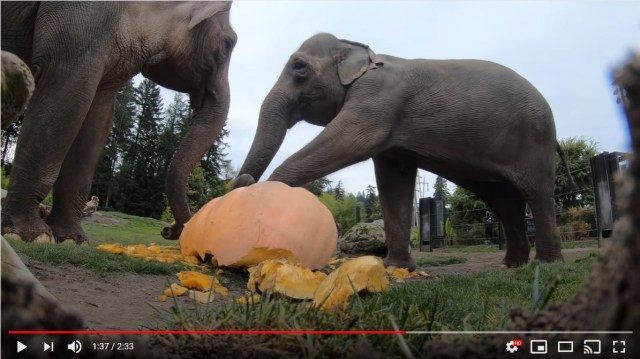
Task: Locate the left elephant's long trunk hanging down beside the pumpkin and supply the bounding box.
[161,86,229,239]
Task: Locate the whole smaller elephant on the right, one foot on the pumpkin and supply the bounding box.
[235,34,562,269]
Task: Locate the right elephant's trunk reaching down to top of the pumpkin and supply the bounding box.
[236,90,293,187]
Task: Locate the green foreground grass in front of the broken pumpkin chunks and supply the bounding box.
[156,255,595,357]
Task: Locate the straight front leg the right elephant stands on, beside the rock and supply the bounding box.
[373,156,417,271]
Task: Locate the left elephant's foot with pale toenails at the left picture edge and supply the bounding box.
[2,213,55,243]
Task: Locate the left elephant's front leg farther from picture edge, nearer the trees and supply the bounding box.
[47,89,116,244]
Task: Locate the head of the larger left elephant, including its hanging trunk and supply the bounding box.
[136,1,237,239]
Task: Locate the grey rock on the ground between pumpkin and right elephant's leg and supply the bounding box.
[339,220,387,256]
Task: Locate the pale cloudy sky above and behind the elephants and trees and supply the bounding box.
[149,0,640,197]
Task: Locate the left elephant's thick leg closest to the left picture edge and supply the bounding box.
[2,65,99,242]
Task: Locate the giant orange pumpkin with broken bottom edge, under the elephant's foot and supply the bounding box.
[180,182,337,269]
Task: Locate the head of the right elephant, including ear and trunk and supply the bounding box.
[235,34,382,187]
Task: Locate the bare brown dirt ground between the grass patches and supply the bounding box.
[21,248,599,330]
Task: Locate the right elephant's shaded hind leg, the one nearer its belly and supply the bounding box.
[475,183,531,267]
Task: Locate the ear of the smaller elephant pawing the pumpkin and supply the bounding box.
[337,40,384,86]
